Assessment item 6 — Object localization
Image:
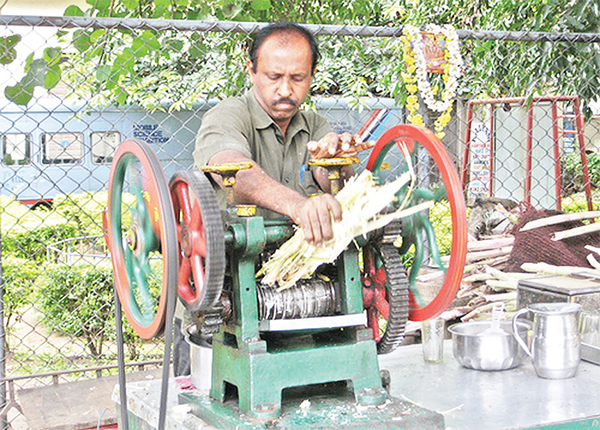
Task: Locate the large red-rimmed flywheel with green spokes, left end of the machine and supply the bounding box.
[106,140,178,339]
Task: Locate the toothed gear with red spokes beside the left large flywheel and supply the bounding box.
[169,171,226,311]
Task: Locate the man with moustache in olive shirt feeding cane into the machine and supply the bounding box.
[194,23,373,244]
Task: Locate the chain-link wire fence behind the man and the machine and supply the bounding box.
[0,16,600,424]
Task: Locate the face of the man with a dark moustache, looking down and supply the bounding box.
[246,33,312,131]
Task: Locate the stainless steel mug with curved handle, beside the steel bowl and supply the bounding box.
[512,303,581,379]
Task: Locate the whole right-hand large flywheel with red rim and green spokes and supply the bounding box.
[367,124,467,321]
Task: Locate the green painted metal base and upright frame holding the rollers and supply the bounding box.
[190,217,387,419]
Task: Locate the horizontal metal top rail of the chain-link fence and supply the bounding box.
[0,15,600,43]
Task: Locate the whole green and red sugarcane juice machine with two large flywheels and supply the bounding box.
[105,125,466,428]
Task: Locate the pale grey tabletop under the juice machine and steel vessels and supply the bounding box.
[113,340,600,430]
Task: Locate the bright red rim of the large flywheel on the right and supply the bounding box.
[367,124,467,321]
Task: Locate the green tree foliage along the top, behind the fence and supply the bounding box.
[0,0,600,109]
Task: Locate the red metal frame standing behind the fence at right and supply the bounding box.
[461,96,593,210]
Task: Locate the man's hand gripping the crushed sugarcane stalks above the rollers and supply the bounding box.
[292,194,342,245]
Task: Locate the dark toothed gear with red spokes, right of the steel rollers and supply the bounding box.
[361,241,408,354]
